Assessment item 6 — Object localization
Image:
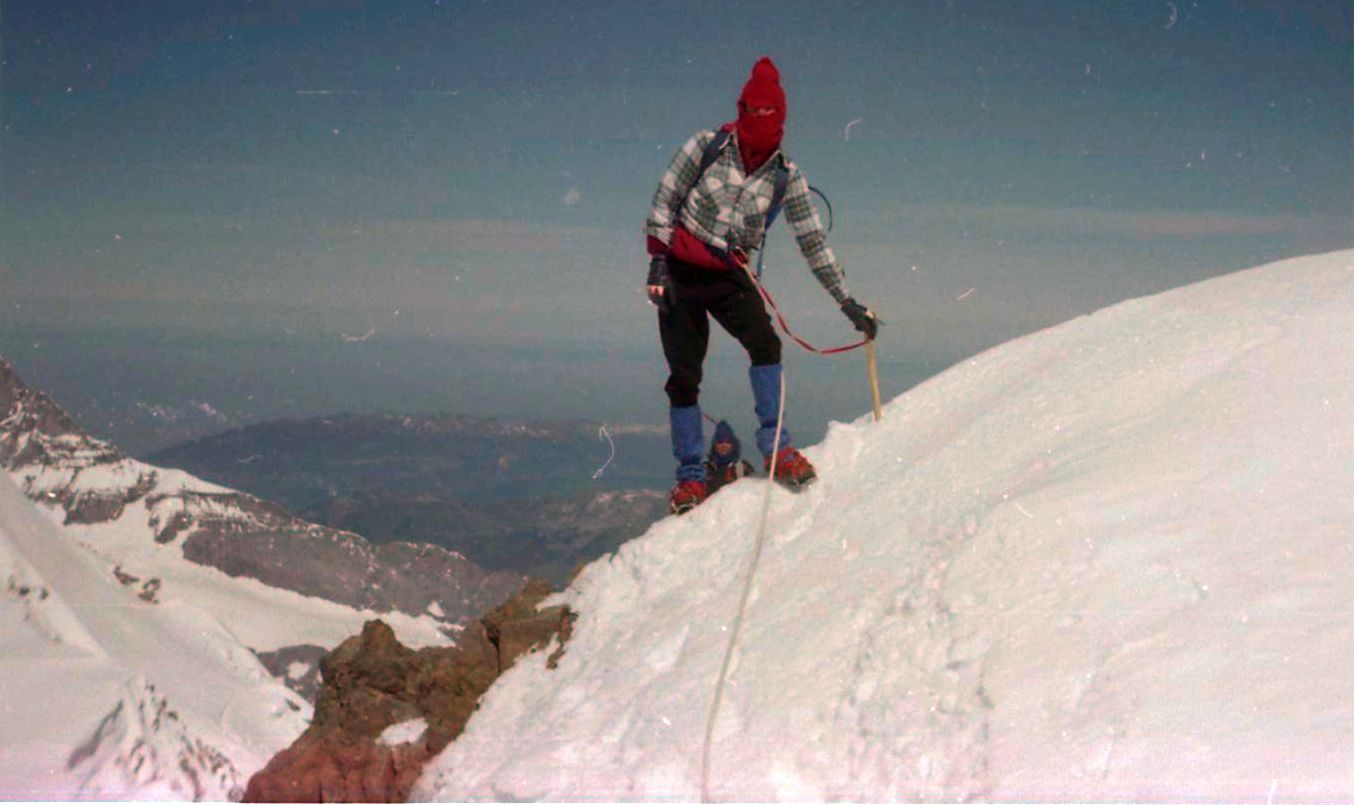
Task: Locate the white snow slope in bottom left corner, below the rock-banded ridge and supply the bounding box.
[0,474,310,800]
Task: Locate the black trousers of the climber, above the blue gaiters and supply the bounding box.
[658,261,780,407]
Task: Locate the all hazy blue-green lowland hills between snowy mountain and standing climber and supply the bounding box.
[150,414,672,586]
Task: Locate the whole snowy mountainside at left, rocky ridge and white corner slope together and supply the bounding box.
[0,361,538,800]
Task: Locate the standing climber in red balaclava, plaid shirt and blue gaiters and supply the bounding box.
[645,57,879,513]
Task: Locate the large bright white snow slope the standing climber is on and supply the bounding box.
[416,252,1354,801]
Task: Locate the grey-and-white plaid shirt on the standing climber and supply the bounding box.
[645,131,850,304]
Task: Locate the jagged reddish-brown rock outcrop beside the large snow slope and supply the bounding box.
[245,580,573,802]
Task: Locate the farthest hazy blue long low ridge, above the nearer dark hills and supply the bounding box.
[146,414,673,510]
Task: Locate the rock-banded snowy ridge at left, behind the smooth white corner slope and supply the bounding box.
[0,361,525,652]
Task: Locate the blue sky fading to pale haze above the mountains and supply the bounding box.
[0,0,1354,438]
